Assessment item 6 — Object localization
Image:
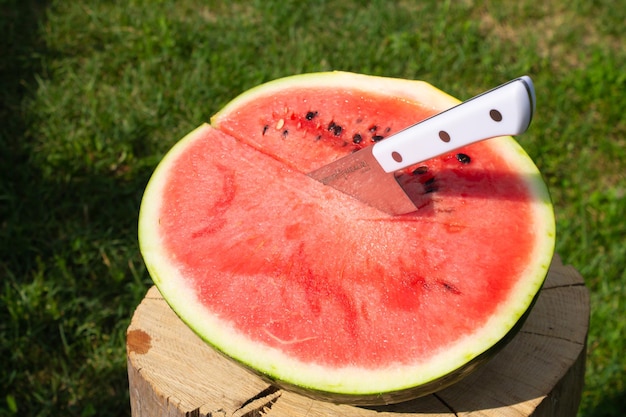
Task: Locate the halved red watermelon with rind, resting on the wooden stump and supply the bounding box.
[139,72,555,404]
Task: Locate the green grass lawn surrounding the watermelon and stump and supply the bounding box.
[0,0,626,417]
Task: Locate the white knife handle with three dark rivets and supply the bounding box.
[372,76,535,172]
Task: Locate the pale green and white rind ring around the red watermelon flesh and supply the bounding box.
[139,73,555,404]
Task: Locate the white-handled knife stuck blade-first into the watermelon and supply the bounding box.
[308,75,535,215]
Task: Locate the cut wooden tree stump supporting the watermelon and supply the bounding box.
[127,256,589,417]
